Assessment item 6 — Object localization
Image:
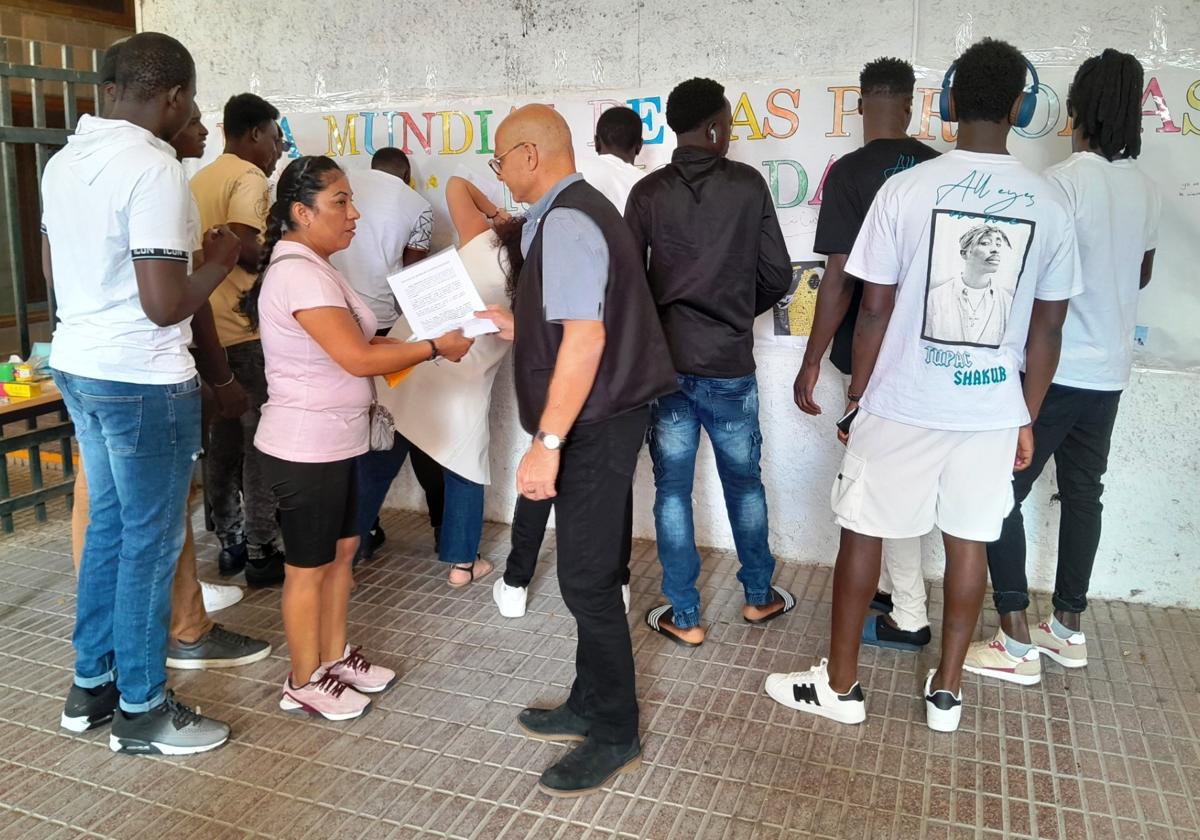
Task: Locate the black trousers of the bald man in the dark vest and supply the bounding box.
[553,408,650,744]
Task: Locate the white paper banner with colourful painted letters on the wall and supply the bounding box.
[201,67,1200,370]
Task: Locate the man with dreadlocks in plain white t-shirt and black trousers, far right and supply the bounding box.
[965,49,1162,684]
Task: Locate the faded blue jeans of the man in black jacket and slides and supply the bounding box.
[650,373,775,629]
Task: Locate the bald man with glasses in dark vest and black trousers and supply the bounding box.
[480,104,676,796]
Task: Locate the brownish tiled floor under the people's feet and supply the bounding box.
[0,503,1200,840]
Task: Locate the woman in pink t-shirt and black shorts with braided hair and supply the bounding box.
[242,156,472,720]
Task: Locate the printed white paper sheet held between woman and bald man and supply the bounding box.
[388,247,499,341]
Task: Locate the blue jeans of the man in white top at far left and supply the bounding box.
[54,371,200,713]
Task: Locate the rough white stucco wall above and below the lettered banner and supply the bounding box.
[139,0,1200,606]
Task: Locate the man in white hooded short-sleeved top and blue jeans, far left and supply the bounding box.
[42,32,240,755]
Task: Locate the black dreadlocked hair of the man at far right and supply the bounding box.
[1067,49,1145,161]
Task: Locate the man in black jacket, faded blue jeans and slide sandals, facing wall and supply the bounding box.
[625,79,796,647]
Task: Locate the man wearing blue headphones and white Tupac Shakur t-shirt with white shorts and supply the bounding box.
[766,38,1082,731]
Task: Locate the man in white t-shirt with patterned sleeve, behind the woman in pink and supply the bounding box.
[330,146,445,560]
